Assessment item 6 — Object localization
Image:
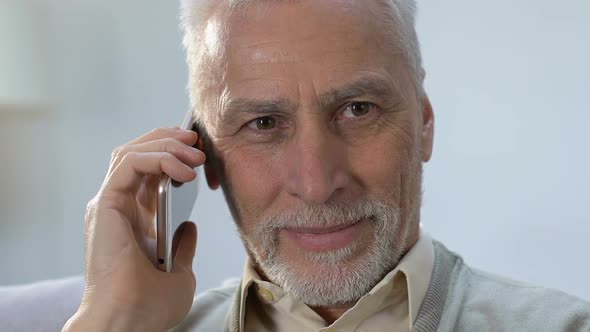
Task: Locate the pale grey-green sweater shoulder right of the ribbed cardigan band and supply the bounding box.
[441,250,590,331]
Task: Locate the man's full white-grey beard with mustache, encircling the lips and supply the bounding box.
[240,199,412,307]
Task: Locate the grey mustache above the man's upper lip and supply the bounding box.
[257,198,395,234]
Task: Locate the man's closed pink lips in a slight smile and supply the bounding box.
[283,219,368,251]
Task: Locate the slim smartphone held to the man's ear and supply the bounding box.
[156,111,199,272]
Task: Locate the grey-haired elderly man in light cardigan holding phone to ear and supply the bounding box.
[2,0,590,331]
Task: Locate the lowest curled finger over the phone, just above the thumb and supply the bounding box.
[104,152,197,193]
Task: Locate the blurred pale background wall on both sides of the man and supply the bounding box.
[0,0,590,300]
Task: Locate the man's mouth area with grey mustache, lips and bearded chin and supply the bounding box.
[240,198,410,307]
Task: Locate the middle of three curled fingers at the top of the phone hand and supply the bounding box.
[111,137,205,169]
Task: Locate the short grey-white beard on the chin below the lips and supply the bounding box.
[259,230,402,307]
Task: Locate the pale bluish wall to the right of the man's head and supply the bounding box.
[419,0,590,299]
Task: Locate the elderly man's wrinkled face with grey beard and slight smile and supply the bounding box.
[202,1,432,306]
